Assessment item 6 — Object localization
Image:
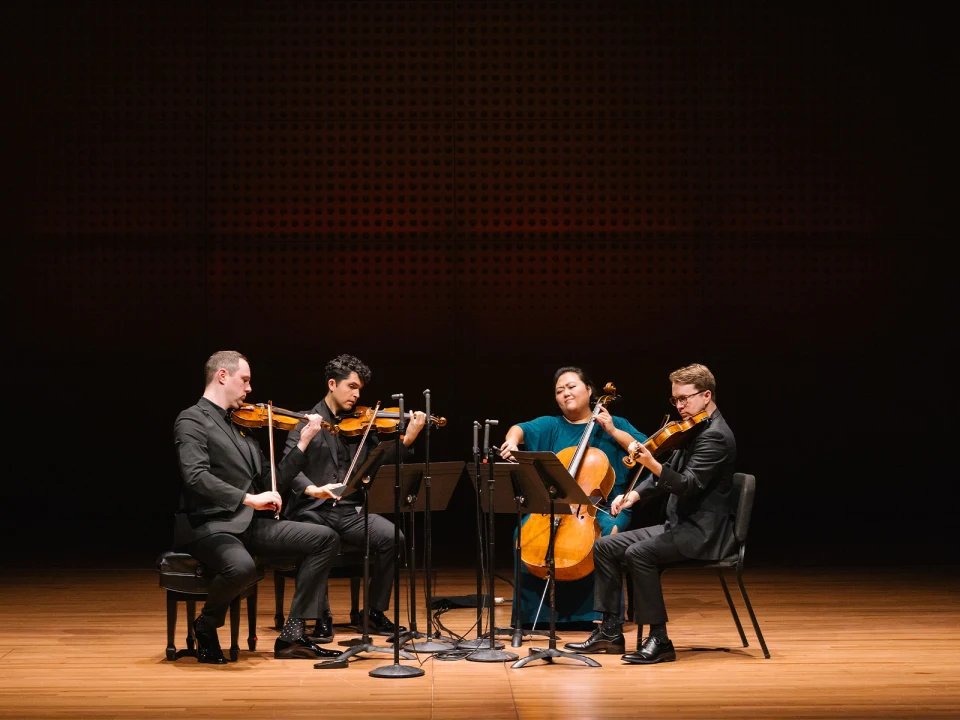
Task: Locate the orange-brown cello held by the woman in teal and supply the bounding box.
[520,383,618,581]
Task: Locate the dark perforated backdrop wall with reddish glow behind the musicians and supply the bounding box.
[4,0,943,565]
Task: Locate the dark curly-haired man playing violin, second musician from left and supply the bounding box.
[286,355,426,643]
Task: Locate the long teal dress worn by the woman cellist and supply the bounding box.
[513,415,647,629]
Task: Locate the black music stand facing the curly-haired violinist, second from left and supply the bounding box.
[371,462,466,652]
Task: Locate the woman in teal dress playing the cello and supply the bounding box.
[500,367,647,630]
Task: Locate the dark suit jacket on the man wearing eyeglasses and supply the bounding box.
[636,410,737,560]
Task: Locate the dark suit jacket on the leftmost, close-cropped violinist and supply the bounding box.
[173,398,308,547]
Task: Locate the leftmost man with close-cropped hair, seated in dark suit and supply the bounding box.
[174,351,340,665]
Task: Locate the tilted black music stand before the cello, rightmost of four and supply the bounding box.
[510,450,601,669]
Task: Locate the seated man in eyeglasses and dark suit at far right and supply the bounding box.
[566,364,737,665]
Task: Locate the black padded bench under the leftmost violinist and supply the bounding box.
[157,552,263,661]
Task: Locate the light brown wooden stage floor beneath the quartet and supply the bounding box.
[0,568,960,720]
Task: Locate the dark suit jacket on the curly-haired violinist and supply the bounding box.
[283,400,412,520]
